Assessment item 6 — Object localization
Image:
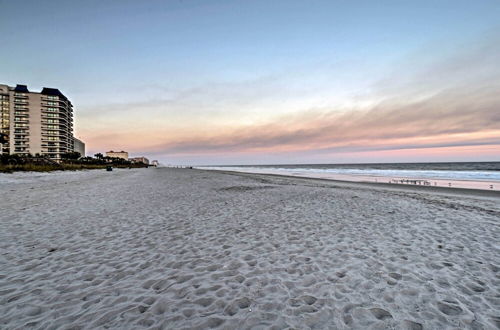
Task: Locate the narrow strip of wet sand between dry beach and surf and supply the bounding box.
[203,168,500,198]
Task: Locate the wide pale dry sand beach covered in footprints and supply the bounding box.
[0,168,500,329]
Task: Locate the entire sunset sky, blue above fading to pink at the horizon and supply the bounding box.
[0,0,500,165]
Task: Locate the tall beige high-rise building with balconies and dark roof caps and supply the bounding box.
[0,85,74,160]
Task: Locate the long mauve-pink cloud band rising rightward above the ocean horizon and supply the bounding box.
[143,78,500,154]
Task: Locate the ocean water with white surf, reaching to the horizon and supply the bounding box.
[197,162,500,190]
